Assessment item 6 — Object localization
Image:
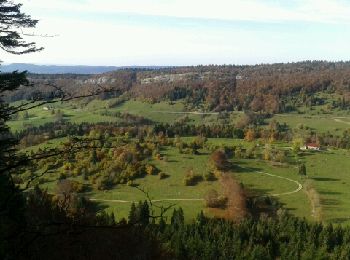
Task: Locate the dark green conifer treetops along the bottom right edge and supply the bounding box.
[153,209,350,260]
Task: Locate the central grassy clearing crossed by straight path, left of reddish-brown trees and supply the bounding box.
[89,148,220,220]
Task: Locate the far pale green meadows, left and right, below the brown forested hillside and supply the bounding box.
[9,97,350,134]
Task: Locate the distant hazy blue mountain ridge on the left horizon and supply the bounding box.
[0,63,167,74]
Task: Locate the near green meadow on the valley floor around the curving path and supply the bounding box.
[21,134,350,224]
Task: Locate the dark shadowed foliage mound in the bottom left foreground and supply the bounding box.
[17,188,167,260]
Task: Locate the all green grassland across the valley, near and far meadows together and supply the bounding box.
[9,97,350,224]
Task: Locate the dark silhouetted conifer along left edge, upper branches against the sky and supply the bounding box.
[0,0,42,259]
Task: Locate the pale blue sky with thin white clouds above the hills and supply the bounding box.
[0,0,350,66]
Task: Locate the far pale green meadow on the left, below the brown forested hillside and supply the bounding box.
[8,100,227,132]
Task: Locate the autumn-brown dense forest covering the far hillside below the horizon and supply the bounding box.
[6,61,350,113]
